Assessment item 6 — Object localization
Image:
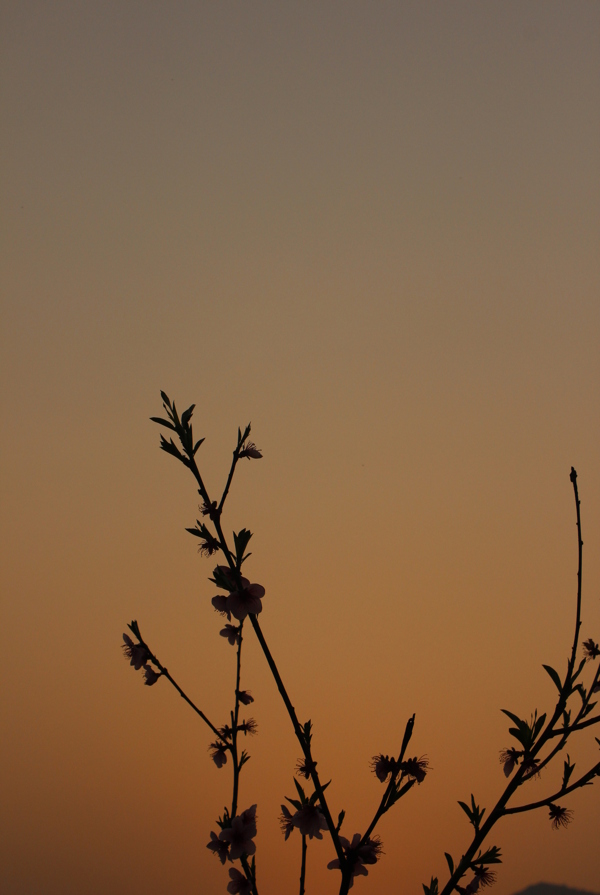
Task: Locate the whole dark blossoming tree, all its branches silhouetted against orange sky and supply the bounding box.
[123,392,600,895]
